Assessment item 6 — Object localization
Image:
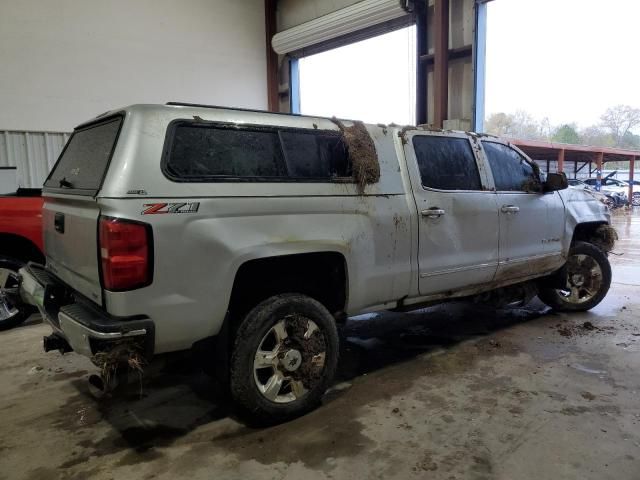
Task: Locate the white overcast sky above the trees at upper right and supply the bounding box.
[485,0,640,127]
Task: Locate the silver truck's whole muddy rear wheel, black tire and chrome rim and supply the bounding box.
[230,293,339,424]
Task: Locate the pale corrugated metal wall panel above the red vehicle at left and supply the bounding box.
[0,130,69,187]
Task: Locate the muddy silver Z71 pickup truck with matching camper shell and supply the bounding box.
[20,104,615,421]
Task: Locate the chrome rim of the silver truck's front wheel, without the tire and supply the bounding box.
[558,254,602,304]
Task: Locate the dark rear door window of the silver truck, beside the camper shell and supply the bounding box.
[413,135,482,190]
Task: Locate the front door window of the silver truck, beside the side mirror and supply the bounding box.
[482,141,542,192]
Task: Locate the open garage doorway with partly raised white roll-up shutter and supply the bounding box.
[271,0,417,123]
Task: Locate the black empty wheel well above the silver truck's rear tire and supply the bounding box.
[229,252,347,318]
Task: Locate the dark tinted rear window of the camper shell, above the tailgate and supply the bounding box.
[44,115,122,195]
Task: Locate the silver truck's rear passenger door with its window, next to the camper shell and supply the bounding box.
[405,131,498,295]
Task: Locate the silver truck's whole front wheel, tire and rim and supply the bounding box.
[538,242,611,312]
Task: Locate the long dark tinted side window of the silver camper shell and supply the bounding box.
[163,121,351,182]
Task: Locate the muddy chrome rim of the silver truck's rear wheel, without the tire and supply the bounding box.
[253,315,326,403]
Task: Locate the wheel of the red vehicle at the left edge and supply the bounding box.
[0,257,34,330]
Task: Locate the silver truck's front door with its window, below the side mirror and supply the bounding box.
[482,140,564,281]
